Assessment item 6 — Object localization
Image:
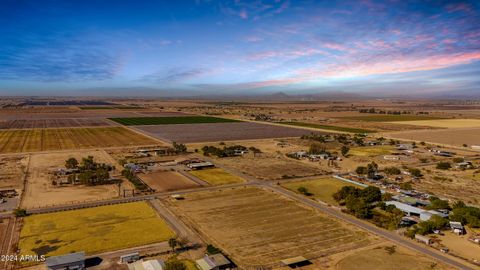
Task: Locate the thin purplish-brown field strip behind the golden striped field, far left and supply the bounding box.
[0,118,112,129]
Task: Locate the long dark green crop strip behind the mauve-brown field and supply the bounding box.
[109,116,240,126]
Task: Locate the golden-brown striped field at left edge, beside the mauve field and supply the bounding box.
[0,127,157,153]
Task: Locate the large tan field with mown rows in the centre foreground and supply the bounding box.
[167,188,374,269]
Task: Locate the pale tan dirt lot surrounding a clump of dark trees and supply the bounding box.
[21,150,133,208]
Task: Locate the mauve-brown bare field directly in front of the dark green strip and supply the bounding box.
[137,122,322,143]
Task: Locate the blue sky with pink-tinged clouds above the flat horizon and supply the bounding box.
[0,0,480,96]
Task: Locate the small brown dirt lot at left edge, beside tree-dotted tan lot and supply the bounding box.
[0,156,28,189]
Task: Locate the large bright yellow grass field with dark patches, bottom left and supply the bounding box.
[19,202,174,256]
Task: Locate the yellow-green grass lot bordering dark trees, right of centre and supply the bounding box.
[282,177,361,205]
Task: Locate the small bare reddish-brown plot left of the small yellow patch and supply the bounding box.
[138,171,200,192]
